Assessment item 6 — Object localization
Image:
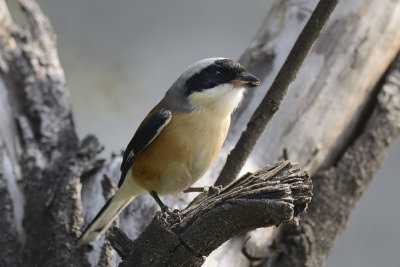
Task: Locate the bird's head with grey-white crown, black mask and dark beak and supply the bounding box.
[166,58,260,115]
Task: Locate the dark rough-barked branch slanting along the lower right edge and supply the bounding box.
[265,54,400,267]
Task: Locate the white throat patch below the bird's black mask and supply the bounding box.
[189,84,244,117]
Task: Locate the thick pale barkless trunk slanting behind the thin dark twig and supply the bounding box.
[203,0,400,266]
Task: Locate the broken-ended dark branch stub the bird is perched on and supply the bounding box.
[108,161,312,266]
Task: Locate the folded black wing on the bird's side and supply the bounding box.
[118,109,172,187]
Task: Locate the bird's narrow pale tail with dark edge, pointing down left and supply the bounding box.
[76,179,140,246]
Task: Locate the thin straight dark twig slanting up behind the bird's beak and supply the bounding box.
[215,0,339,186]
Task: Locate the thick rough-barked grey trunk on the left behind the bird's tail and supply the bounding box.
[0,1,101,266]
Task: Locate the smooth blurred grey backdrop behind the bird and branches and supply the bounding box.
[6,0,400,267]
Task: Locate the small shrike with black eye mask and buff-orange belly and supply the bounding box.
[77,57,260,246]
